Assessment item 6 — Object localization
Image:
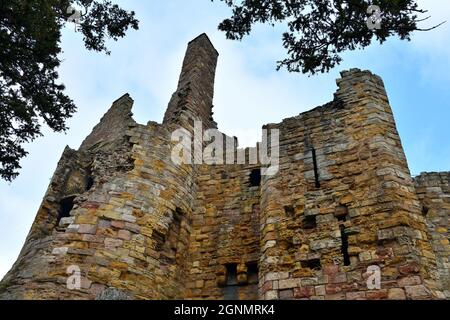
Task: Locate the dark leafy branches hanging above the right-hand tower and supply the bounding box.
[212,0,439,74]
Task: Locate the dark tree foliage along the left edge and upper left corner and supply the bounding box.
[0,0,138,181]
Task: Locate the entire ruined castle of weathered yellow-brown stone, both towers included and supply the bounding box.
[0,35,450,300]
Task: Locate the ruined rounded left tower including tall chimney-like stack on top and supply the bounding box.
[0,35,217,299]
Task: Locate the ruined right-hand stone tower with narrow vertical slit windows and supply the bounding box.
[260,69,442,299]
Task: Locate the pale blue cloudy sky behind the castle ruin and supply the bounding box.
[0,0,450,279]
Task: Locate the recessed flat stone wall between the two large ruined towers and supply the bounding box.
[186,160,260,299]
